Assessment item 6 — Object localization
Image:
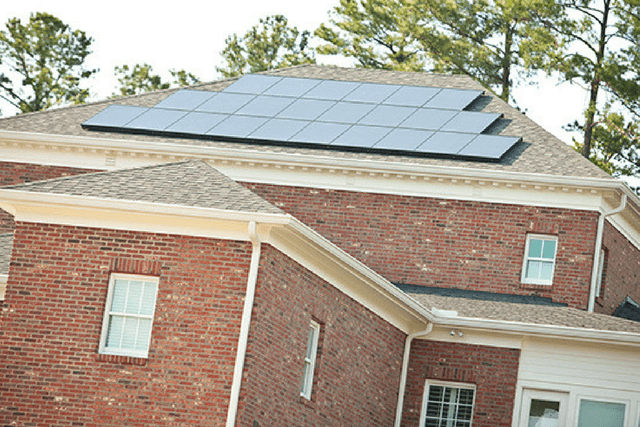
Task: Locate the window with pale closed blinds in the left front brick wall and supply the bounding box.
[100,274,158,357]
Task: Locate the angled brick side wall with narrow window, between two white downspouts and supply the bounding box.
[238,247,405,427]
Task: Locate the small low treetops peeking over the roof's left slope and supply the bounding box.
[114,64,199,96]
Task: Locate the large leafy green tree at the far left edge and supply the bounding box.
[0,13,97,112]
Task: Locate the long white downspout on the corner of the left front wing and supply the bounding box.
[226,221,260,427]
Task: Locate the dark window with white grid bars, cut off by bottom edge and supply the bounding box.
[420,381,475,427]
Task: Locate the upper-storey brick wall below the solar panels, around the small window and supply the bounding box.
[245,183,598,308]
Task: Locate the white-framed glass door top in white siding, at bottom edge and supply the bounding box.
[519,389,569,427]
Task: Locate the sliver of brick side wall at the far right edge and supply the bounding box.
[595,221,640,314]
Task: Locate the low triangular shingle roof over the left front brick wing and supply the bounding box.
[3,160,283,214]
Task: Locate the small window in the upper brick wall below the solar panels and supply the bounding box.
[522,234,558,285]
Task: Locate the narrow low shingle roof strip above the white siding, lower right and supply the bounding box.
[406,292,640,333]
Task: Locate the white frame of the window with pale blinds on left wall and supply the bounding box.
[98,273,160,359]
